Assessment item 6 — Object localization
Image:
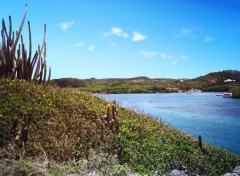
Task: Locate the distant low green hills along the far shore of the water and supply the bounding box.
[50,70,240,98]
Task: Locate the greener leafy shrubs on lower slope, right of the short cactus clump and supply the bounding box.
[117,109,240,175]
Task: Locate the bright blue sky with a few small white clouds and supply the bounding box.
[0,0,240,79]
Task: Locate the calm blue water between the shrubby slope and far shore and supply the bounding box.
[100,93,240,154]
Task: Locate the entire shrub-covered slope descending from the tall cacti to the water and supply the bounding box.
[0,79,240,175]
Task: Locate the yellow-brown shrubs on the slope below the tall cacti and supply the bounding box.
[0,80,114,161]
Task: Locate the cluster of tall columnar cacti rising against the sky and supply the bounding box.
[0,5,51,85]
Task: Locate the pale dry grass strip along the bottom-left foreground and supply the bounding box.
[0,153,137,176]
